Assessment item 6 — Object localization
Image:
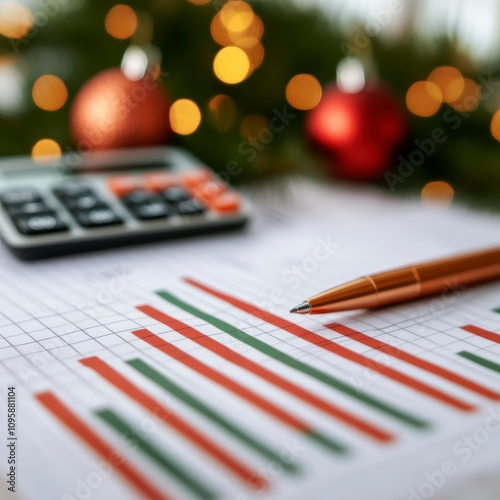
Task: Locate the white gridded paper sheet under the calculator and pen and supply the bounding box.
[0,182,500,500]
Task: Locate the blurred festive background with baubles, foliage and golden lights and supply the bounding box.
[0,0,500,209]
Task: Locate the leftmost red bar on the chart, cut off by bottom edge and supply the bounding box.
[35,392,169,500]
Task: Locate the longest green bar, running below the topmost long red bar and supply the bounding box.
[156,291,429,429]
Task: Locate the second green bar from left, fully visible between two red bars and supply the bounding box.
[127,359,299,468]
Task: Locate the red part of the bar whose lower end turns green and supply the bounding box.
[132,328,313,432]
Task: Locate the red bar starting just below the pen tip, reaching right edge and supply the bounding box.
[325,323,500,401]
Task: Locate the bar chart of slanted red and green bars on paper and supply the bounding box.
[21,278,500,499]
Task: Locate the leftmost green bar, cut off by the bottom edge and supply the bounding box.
[96,408,217,499]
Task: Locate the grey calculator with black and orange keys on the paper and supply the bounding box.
[0,147,249,260]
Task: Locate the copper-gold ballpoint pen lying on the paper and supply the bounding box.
[290,248,500,314]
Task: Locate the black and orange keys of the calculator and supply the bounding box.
[0,168,241,243]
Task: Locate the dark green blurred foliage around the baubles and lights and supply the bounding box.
[0,0,500,204]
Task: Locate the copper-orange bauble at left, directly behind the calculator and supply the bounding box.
[70,68,170,150]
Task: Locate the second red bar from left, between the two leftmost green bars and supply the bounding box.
[80,356,268,489]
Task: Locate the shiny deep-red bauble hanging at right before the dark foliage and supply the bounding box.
[306,83,407,180]
